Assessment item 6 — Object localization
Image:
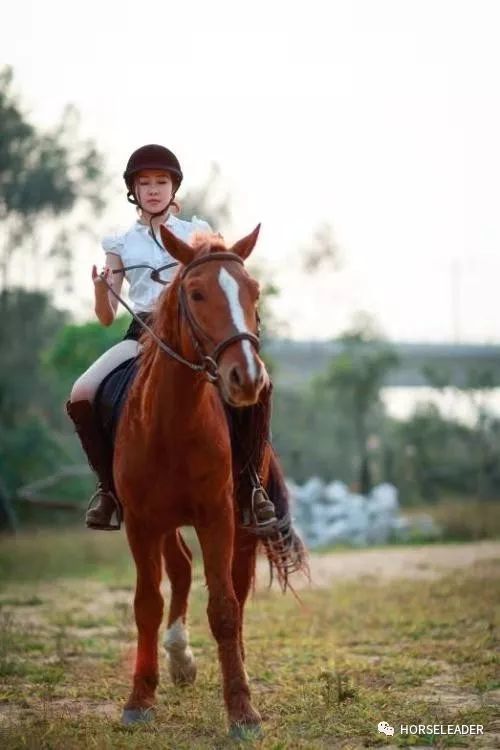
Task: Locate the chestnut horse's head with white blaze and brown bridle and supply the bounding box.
[160,225,269,406]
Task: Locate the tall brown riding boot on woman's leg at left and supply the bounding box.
[66,401,122,531]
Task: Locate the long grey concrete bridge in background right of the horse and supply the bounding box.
[264,339,500,388]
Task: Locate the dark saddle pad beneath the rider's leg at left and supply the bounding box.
[94,357,138,445]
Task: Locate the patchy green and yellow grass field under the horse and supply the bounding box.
[0,531,500,750]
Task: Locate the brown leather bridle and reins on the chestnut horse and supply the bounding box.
[101,251,260,383]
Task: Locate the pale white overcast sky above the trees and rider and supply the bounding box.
[0,0,500,343]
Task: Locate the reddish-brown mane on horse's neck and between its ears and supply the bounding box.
[140,231,228,367]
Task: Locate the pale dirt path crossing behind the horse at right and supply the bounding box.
[259,541,500,588]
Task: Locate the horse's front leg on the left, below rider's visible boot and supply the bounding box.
[122,523,163,724]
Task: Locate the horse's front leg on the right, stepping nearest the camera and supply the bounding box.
[196,512,260,737]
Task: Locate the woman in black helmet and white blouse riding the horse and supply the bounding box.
[67,144,296,543]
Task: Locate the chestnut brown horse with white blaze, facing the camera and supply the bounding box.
[114,227,286,736]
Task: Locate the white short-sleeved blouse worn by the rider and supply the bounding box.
[102,216,212,313]
